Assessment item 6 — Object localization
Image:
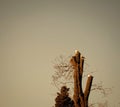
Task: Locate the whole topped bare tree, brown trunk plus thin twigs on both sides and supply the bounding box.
[52,51,109,107]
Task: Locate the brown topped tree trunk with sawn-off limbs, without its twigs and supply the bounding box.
[70,51,93,107]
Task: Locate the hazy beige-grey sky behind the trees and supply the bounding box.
[0,0,120,107]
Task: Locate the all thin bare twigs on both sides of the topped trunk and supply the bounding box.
[52,55,111,107]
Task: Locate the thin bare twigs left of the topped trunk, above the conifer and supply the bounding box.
[52,55,73,90]
